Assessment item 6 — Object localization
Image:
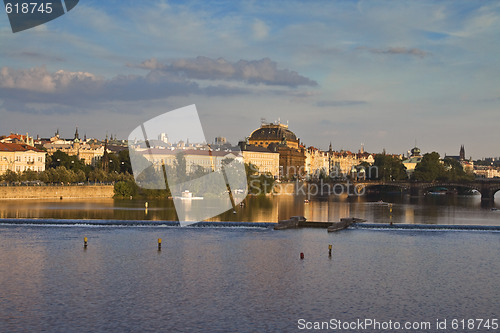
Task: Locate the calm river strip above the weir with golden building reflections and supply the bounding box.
[0,194,500,225]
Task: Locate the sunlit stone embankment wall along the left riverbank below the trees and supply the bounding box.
[0,185,114,200]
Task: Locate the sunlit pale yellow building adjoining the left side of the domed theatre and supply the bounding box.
[238,142,280,179]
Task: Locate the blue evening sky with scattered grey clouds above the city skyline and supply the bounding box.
[0,0,500,159]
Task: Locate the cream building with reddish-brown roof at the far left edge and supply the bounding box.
[0,142,46,175]
